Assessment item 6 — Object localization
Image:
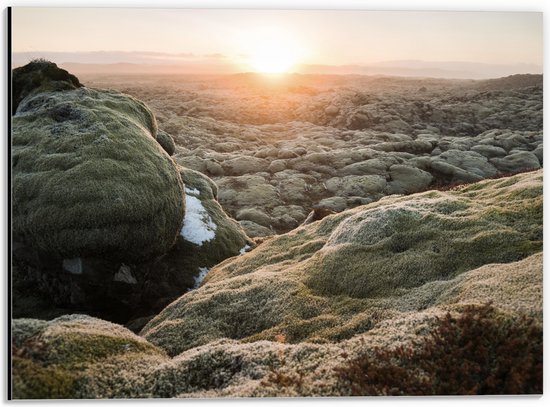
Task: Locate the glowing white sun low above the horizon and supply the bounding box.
[248,30,301,74]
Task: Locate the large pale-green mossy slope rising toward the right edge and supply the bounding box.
[142,171,542,355]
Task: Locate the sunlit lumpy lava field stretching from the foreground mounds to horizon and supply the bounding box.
[86,74,543,237]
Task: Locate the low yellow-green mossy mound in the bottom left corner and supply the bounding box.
[12,315,166,399]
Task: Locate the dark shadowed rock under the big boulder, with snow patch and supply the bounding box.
[10,167,253,330]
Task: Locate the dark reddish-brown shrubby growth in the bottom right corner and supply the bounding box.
[338,304,543,396]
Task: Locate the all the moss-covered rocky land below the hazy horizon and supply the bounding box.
[11,61,543,399]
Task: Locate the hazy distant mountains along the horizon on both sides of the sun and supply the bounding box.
[12,52,543,79]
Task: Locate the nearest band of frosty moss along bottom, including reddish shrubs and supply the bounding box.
[12,253,542,399]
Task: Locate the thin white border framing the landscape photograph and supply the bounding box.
[0,0,550,407]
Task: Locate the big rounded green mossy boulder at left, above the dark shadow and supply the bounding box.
[12,73,185,261]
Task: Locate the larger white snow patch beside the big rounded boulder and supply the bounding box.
[180,194,218,246]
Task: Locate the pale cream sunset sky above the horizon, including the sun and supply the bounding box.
[12,7,543,75]
